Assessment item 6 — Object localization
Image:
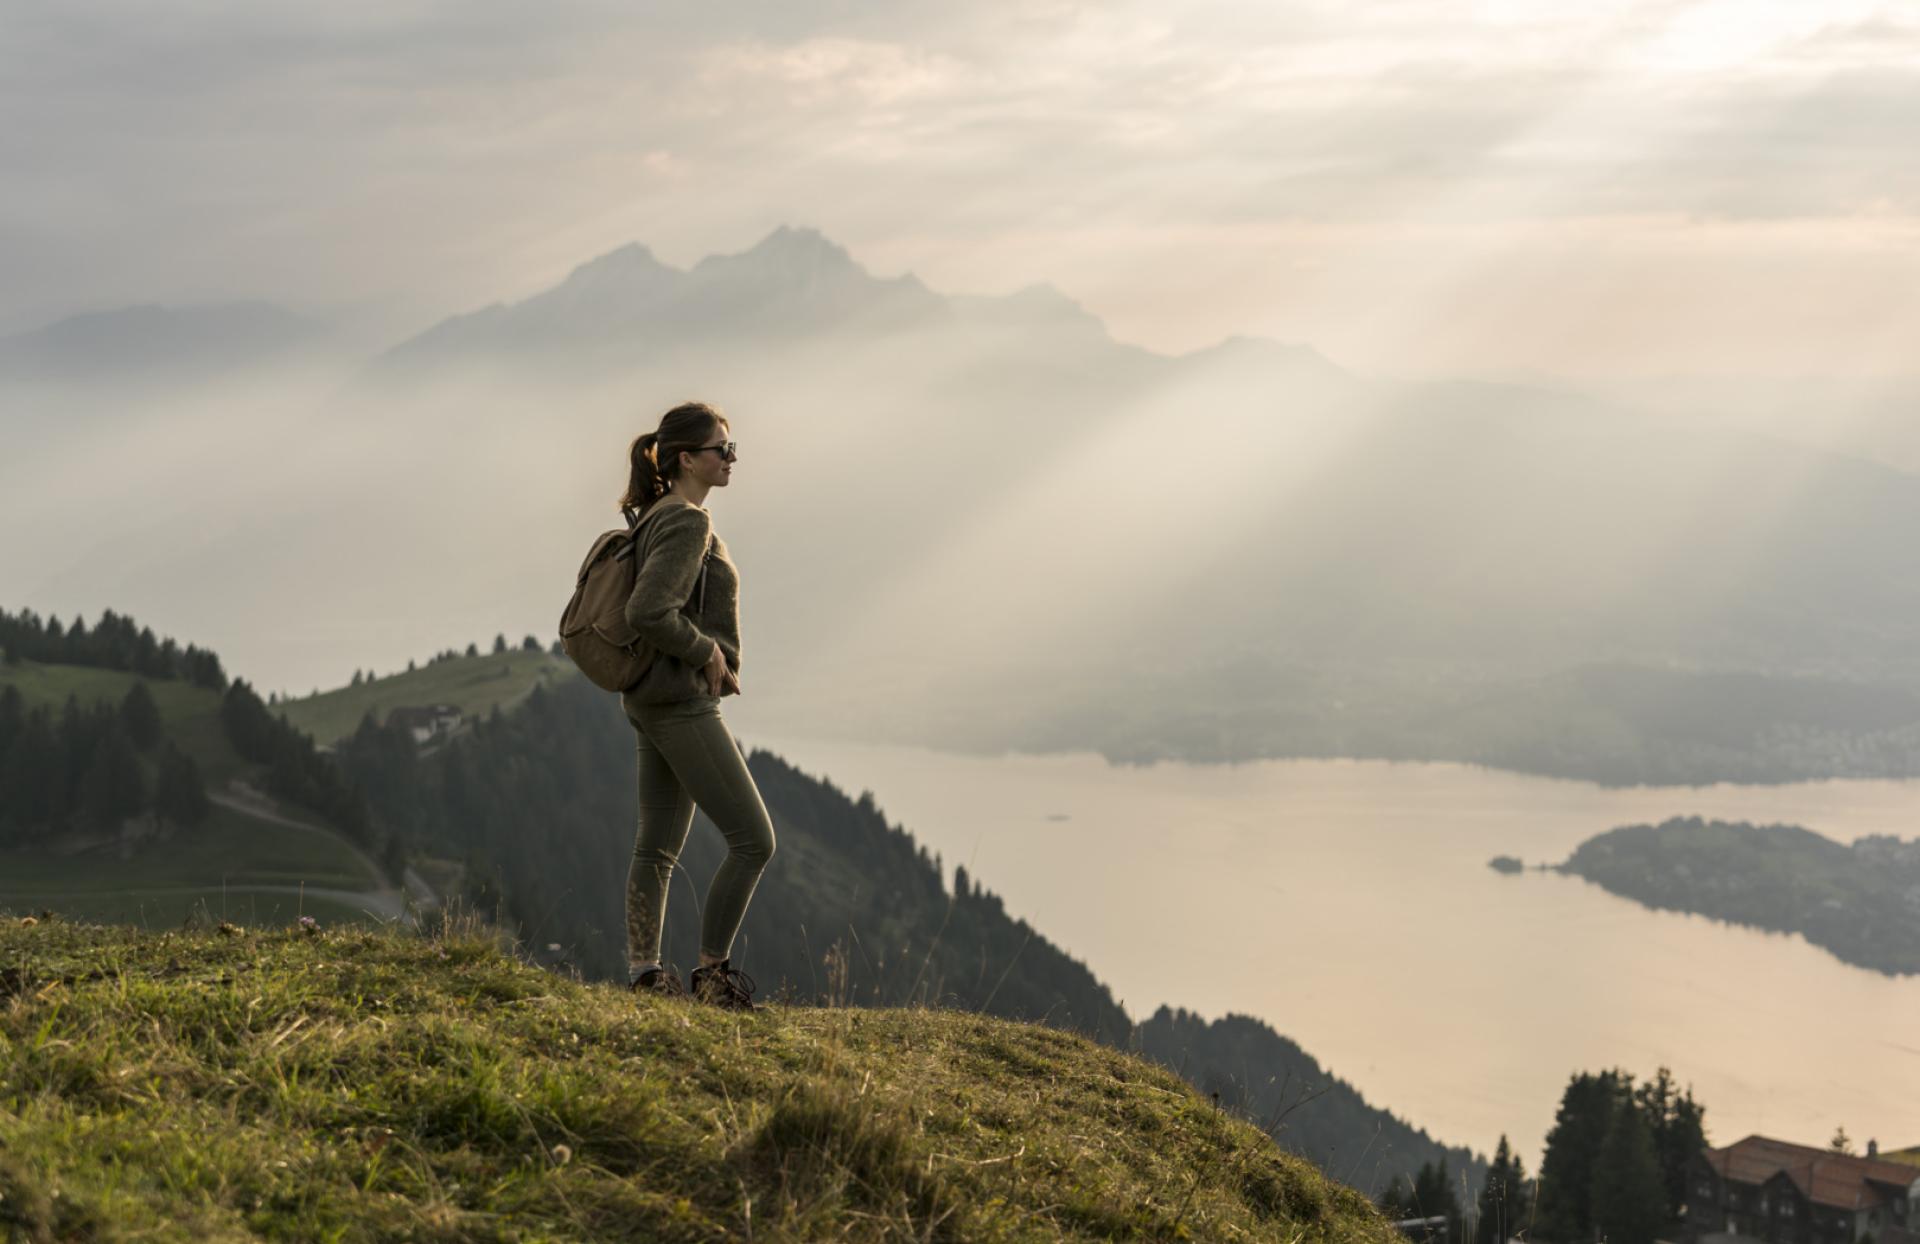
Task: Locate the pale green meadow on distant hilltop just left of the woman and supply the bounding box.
[275,649,576,743]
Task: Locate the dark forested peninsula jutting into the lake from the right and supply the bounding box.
[1557,816,1920,975]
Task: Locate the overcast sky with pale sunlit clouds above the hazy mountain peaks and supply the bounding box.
[0,0,1920,376]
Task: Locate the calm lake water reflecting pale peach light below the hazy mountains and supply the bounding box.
[737,728,1920,1173]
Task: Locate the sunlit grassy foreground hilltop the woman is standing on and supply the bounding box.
[0,921,1396,1244]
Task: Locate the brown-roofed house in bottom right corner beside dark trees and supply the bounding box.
[1686,1136,1920,1244]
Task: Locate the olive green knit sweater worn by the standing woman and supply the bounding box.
[626,493,739,698]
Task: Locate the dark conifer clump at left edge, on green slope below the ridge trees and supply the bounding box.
[0,682,209,847]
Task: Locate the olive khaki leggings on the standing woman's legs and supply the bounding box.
[626,695,774,966]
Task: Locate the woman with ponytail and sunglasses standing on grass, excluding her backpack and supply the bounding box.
[620,401,774,1010]
